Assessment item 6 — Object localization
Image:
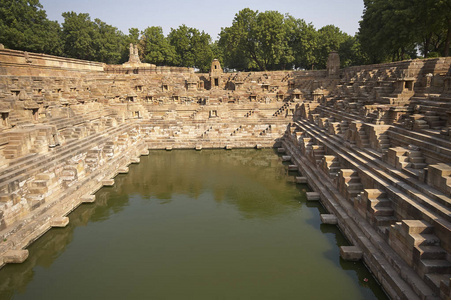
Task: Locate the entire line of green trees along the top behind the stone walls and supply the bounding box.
[8,0,451,72]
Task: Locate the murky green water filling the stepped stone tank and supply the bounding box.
[0,150,386,299]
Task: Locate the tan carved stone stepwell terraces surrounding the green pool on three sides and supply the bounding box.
[0,47,451,299]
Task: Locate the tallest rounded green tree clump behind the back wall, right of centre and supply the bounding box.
[218,8,363,70]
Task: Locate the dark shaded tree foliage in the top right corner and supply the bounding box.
[358,0,451,63]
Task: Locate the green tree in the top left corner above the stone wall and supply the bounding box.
[0,0,62,55]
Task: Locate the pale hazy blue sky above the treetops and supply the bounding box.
[40,0,363,40]
